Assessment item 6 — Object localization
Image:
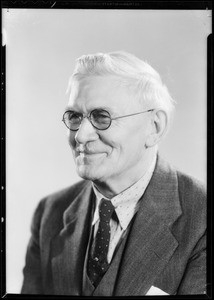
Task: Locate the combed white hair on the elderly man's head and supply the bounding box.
[68,51,174,120]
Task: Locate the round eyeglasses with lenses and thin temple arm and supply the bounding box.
[62,109,154,131]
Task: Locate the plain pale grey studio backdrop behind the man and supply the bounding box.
[3,9,211,293]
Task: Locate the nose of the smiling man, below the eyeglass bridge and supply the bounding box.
[75,118,99,144]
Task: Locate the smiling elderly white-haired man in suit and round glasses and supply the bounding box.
[22,52,206,296]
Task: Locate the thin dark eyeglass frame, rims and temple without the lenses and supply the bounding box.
[62,108,155,131]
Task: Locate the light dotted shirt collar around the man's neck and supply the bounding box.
[92,156,156,230]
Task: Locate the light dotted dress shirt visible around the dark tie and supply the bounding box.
[92,156,156,263]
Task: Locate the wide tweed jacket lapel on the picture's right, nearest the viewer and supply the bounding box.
[115,157,181,296]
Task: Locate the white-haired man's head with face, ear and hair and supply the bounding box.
[66,52,173,189]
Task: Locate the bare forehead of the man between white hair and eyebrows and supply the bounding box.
[69,75,140,111]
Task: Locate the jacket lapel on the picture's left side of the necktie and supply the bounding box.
[51,180,93,295]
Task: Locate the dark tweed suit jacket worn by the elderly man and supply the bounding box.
[22,157,206,296]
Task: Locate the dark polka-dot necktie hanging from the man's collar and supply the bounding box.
[88,199,115,286]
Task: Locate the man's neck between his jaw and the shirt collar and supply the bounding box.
[94,151,156,199]
